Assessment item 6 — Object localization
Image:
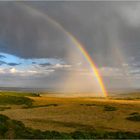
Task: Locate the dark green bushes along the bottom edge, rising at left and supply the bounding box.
[0,115,140,139]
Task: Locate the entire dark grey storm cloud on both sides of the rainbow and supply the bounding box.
[0,1,140,67]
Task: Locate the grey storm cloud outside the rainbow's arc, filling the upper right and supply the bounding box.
[27,1,140,66]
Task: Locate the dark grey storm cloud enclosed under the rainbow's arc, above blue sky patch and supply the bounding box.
[0,2,68,58]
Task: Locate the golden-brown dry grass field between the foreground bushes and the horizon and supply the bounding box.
[0,96,140,132]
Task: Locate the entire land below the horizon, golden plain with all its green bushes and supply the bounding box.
[0,91,140,139]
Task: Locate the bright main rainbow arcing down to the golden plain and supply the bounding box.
[18,3,107,97]
